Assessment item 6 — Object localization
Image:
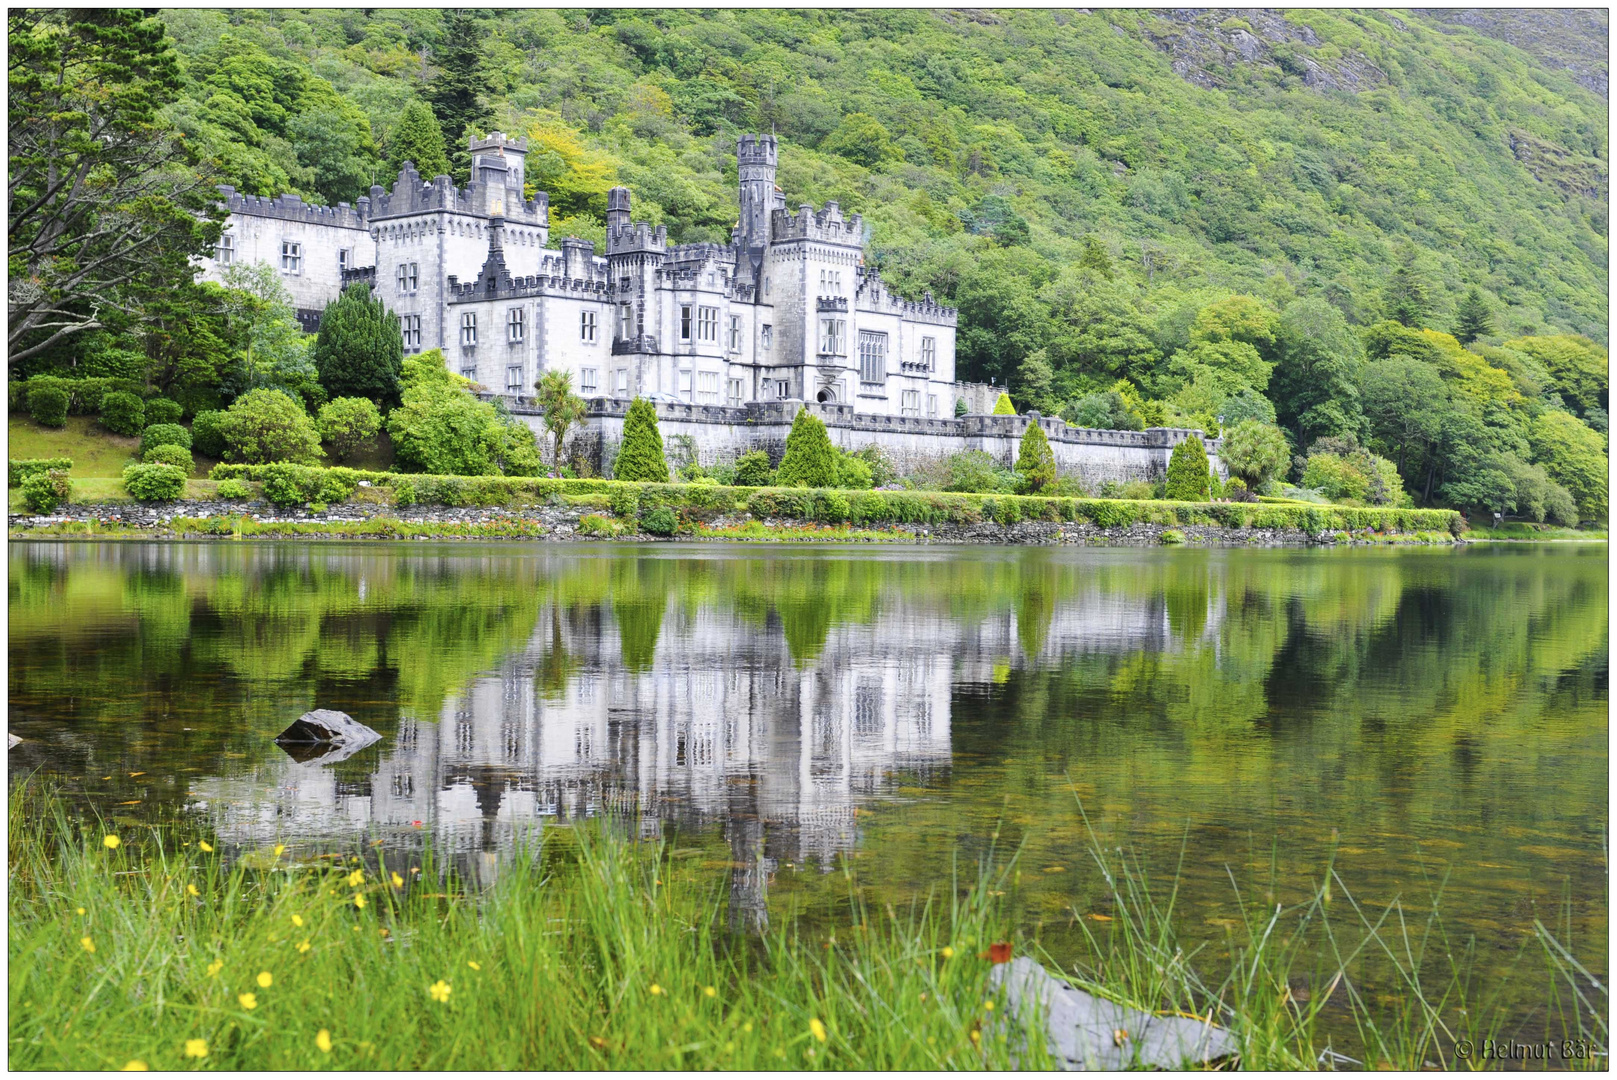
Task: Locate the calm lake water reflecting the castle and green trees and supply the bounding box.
[8,543,1609,1028]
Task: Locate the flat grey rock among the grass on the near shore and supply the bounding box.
[990,957,1235,1070]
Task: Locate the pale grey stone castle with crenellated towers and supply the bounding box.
[204,131,964,417]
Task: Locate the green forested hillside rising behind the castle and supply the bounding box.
[12,10,1609,517]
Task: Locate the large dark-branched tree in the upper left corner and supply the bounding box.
[6,8,223,373]
